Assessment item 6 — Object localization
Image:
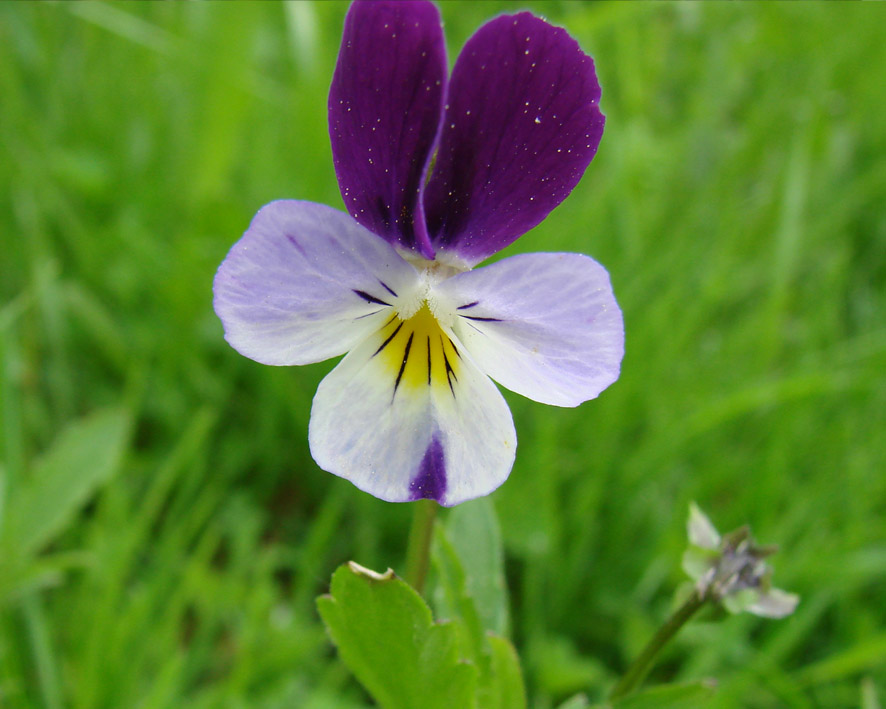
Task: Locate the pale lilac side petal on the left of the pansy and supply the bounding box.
[213,200,418,365]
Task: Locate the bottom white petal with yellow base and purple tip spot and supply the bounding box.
[308,309,517,506]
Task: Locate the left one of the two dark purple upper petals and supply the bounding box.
[329,0,446,258]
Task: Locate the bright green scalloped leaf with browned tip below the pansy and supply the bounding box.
[317,562,477,709]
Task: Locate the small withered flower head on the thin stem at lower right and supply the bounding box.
[683,502,800,618]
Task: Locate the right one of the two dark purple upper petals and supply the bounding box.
[424,12,604,263]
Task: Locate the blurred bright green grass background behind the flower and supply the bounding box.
[0,2,886,709]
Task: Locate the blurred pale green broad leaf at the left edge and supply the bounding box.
[2,408,130,558]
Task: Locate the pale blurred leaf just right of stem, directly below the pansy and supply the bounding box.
[446,497,508,637]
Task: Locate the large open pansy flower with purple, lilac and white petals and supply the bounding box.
[214,1,624,506]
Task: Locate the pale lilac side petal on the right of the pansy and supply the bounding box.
[437,253,624,406]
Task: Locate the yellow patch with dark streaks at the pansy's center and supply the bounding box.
[375,302,461,395]
